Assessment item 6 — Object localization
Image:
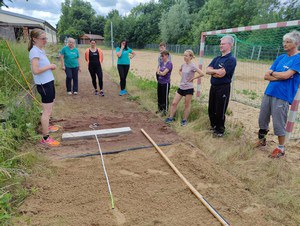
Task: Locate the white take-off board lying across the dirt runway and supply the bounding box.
[62,127,132,140]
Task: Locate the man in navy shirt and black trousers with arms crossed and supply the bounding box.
[206,35,236,137]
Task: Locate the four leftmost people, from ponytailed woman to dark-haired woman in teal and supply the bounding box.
[28,28,135,146]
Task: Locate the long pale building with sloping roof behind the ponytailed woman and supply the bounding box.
[0,9,57,43]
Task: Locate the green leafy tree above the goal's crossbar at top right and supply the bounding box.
[192,0,296,44]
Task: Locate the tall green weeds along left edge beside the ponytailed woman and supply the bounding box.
[0,40,52,225]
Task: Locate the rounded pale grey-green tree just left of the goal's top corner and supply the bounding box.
[159,0,191,44]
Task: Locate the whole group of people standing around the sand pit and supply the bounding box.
[28,29,300,158]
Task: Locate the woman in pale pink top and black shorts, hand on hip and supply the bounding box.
[165,49,204,126]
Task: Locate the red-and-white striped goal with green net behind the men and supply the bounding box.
[197,20,300,139]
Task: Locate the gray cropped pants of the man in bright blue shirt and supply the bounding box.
[258,95,289,136]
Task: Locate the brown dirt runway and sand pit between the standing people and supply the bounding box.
[15,48,282,226]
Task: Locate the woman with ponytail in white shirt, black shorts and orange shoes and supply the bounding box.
[28,28,60,146]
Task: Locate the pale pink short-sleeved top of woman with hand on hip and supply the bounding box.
[179,62,197,90]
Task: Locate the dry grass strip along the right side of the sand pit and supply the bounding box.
[105,65,300,225]
